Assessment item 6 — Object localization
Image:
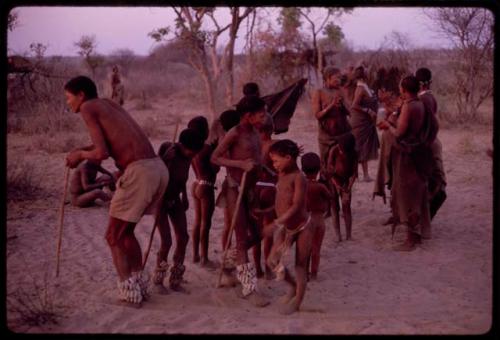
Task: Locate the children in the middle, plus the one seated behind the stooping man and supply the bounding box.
[71,79,357,314]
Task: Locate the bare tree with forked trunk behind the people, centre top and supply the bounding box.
[149,7,254,119]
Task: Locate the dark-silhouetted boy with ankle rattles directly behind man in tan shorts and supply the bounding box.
[153,128,204,294]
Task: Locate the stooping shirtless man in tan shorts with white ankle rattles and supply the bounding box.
[64,76,168,306]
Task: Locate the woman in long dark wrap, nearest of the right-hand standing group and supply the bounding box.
[378,76,437,251]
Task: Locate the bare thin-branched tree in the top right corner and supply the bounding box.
[424,7,494,120]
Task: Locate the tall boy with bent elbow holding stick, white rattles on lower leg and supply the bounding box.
[211,96,269,307]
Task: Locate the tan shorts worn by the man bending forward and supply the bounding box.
[109,157,169,223]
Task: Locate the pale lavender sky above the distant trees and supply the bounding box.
[7,7,450,56]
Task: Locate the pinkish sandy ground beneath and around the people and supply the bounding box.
[6,100,493,334]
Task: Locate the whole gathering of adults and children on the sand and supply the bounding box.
[64,63,445,314]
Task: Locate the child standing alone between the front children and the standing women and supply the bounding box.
[327,132,358,242]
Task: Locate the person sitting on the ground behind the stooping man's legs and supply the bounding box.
[69,159,115,208]
